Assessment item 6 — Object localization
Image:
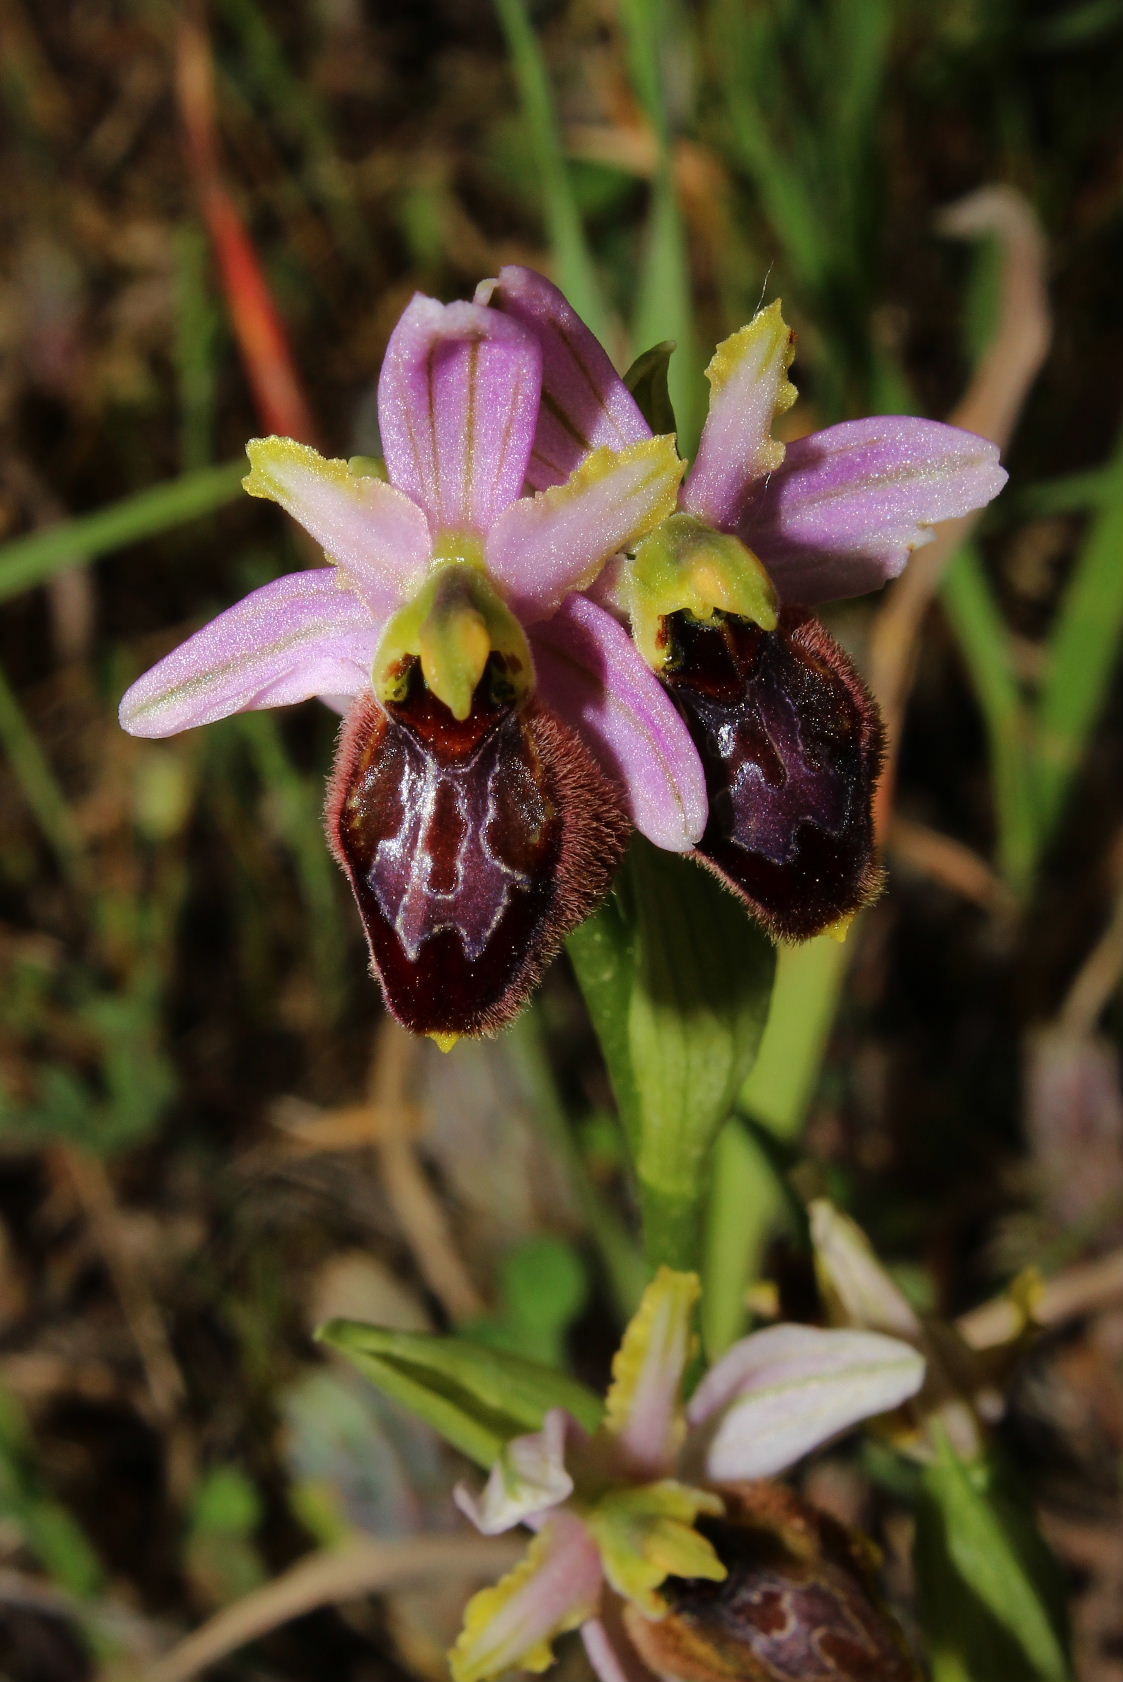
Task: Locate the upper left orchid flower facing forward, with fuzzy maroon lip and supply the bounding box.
[121,294,706,1045]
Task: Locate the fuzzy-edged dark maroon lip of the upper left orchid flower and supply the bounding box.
[326,669,629,1034]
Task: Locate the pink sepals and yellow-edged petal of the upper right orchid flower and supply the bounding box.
[476,264,1007,607]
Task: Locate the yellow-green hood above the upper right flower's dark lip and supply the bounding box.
[627,513,780,671]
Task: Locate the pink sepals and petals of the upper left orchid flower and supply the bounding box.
[121,294,706,851]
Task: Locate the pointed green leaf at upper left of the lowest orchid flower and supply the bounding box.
[316,1320,602,1467]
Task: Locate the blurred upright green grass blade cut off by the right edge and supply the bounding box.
[1036,437,1123,849]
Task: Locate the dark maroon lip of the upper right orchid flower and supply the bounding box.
[664,607,883,940]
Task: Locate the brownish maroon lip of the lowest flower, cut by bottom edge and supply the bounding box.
[625,1484,920,1682]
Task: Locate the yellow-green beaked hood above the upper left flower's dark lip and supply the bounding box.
[372,555,535,718]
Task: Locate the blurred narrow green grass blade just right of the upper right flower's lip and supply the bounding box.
[941,543,1039,897]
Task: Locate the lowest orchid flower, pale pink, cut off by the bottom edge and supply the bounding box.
[451,1268,925,1682]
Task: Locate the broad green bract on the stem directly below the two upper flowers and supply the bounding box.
[627,839,775,1267]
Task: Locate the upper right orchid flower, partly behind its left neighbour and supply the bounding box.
[476,266,1005,939]
